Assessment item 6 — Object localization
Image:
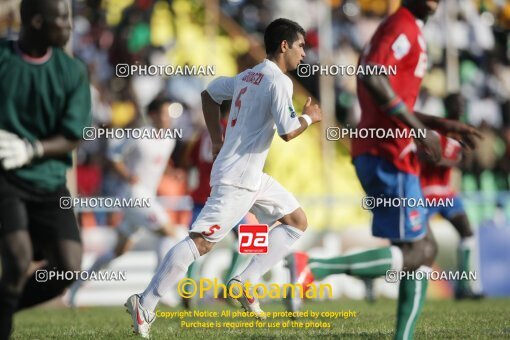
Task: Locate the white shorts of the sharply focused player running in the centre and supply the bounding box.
[190,174,300,242]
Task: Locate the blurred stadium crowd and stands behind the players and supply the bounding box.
[0,0,510,305]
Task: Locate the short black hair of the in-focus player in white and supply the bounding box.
[264,18,305,55]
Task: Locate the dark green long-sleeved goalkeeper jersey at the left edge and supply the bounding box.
[0,40,91,191]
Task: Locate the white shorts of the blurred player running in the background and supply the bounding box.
[118,184,169,237]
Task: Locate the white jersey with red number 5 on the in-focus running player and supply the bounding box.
[207,59,301,191]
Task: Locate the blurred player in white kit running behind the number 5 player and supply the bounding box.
[69,98,180,306]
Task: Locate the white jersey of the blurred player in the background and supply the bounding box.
[107,127,175,196]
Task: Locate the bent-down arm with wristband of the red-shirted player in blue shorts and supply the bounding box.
[360,73,441,163]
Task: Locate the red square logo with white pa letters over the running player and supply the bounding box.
[239,224,269,254]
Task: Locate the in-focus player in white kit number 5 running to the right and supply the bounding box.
[126,19,321,337]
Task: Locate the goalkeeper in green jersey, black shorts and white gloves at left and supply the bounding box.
[0,0,91,339]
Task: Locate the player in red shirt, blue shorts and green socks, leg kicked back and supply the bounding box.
[287,0,477,339]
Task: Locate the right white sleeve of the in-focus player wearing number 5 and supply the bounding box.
[271,78,301,136]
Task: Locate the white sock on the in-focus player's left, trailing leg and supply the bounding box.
[140,236,200,312]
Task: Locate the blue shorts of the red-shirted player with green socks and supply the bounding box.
[353,154,428,242]
